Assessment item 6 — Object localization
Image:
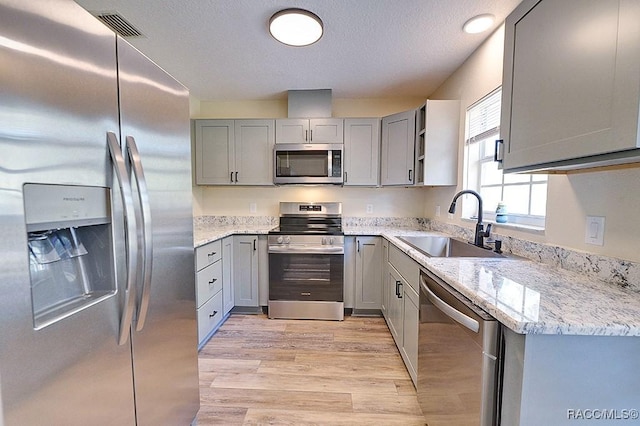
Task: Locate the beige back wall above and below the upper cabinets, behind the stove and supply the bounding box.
[191,98,426,217]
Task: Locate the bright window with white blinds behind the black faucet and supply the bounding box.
[462,89,547,228]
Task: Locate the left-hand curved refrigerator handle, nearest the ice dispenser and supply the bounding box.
[107,132,138,345]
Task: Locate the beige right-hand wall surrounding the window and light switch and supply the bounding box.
[424,24,640,261]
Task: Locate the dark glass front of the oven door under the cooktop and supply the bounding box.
[269,253,344,302]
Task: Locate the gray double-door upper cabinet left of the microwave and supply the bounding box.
[195,120,275,185]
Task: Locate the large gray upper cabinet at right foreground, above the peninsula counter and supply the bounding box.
[498,0,640,172]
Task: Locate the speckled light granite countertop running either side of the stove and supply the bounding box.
[195,226,640,336]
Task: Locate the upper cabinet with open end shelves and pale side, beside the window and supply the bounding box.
[416,99,460,186]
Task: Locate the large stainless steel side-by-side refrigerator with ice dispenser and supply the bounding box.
[0,0,199,426]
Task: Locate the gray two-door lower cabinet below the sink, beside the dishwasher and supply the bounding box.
[384,244,420,385]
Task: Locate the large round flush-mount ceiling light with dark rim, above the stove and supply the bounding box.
[269,9,323,46]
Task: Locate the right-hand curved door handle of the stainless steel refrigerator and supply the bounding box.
[126,136,153,331]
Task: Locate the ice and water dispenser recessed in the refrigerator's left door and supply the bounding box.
[24,184,115,329]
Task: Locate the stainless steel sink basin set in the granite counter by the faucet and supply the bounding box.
[398,235,507,259]
